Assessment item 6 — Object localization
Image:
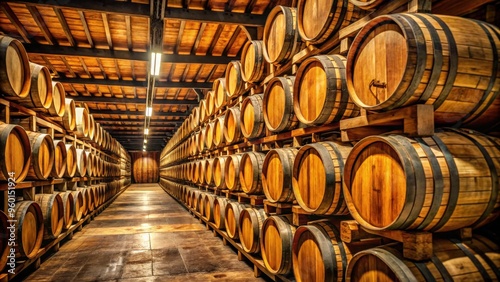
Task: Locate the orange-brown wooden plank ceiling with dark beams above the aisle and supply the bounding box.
[0,0,286,150]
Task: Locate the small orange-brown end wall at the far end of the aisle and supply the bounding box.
[130,152,160,183]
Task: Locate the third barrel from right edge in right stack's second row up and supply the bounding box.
[261,148,299,203]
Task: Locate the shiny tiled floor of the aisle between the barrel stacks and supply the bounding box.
[26,184,263,281]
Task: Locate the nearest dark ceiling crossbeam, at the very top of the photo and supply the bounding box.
[8,0,267,26]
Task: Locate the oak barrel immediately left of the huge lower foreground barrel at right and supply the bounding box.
[292,142,352,215]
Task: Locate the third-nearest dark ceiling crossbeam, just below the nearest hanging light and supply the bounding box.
[54,77,213,89]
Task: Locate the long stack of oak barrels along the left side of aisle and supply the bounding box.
[0,36,130,270]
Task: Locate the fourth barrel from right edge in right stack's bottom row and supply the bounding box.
[239,208,267,253]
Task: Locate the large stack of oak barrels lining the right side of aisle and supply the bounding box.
[160,0,500,281]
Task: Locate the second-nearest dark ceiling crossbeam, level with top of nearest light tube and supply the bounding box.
[24,43,236,65]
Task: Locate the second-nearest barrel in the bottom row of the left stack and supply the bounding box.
[35,194,64,240]
